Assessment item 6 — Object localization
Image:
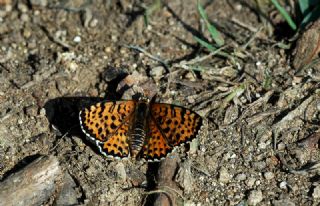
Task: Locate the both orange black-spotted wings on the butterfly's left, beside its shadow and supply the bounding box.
[79,100,136,158]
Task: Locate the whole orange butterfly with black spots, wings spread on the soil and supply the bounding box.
[79,100,202,161]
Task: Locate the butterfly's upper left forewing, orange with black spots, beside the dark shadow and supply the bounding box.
[79,100,136,142]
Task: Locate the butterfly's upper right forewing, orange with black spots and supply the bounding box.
[150,103,202,146]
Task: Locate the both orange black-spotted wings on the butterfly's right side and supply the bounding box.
[143,103,202,160]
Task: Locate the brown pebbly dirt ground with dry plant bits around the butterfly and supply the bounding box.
[0,0,320,206]
